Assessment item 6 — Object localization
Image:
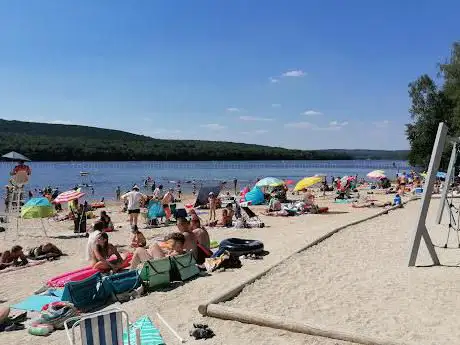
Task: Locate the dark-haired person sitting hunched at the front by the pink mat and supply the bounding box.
[92,232,123,273]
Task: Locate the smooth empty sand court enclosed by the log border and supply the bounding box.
[225,201,460,345]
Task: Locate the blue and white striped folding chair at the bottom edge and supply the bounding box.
[64,308,141,345]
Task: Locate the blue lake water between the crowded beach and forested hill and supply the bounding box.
[0,160,409,199]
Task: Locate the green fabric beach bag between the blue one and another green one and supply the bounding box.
[139,257,171,291]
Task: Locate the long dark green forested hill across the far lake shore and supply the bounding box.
[0,119,408,161]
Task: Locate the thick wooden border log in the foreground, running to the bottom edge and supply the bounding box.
[208,304,404,345]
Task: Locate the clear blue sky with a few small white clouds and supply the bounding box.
[0,0,460,149]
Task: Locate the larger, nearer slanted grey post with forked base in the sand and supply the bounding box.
[409,122,448,266]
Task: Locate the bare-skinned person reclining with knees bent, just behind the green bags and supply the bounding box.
[130,232,185,270]
